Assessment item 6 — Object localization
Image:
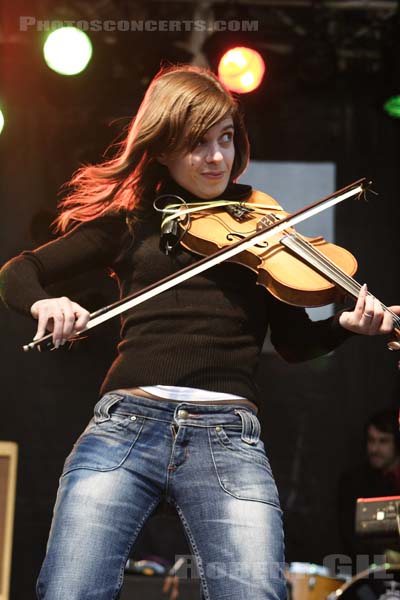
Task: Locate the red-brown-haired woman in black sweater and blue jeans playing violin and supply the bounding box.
[1,66,400,600]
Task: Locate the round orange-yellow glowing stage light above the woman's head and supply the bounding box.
[218,46,265,94]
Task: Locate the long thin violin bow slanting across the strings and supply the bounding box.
[22,177,372,352]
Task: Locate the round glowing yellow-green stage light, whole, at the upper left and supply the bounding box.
[43,27,93,75]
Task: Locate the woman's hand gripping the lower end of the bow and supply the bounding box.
[31,296,90,348]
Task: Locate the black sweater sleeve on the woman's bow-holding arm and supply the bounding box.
[0,215,127,315]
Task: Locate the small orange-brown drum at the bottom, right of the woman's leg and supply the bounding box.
[286,562,344,600]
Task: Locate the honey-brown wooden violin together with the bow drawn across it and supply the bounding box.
[23,178,400,351]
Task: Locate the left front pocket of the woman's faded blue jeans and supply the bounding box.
[62,394,145,476]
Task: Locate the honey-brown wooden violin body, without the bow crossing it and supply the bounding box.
[179,191,357,307]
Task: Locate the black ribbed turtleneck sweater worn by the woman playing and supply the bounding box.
[0,184,349,401]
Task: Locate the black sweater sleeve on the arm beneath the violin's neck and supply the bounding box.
[268,294,355,363]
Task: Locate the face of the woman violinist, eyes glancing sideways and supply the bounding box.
[158,117,235,200]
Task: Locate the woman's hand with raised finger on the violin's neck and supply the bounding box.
[339,284,400,335]
